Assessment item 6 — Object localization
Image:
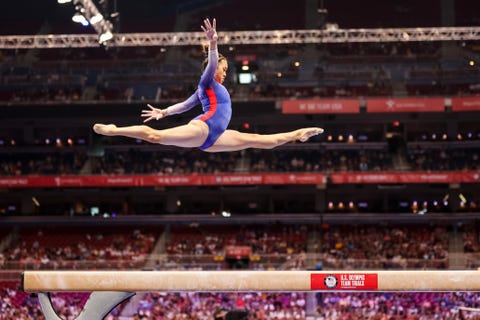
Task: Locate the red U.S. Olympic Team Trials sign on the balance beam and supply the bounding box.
[310,273,378,291]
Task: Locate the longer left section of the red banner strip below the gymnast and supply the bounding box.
[0,173,326,188]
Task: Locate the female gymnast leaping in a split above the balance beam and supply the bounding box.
[93,19,323,152]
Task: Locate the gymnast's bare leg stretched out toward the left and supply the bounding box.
[93,120,209,148]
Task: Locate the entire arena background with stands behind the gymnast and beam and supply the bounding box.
[0,0,480,320]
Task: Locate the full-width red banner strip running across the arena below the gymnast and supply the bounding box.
[0,171,480,188]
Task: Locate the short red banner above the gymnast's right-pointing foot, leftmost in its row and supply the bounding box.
[282,99,360,114]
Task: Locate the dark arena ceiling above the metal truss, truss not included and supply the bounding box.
[0,0,480,35]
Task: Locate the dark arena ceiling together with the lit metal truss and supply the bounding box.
[0,0,480,49]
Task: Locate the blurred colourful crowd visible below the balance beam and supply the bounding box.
[0,285,480,320]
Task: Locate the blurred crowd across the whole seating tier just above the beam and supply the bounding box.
[0,225,468,270]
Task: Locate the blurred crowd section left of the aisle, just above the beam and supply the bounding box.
[0,228,156,270]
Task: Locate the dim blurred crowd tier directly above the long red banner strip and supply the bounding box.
[0,145,480,176]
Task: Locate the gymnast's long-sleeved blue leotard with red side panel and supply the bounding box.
[167,50,232,150]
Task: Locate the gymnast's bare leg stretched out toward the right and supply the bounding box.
[205,127,323,152]
